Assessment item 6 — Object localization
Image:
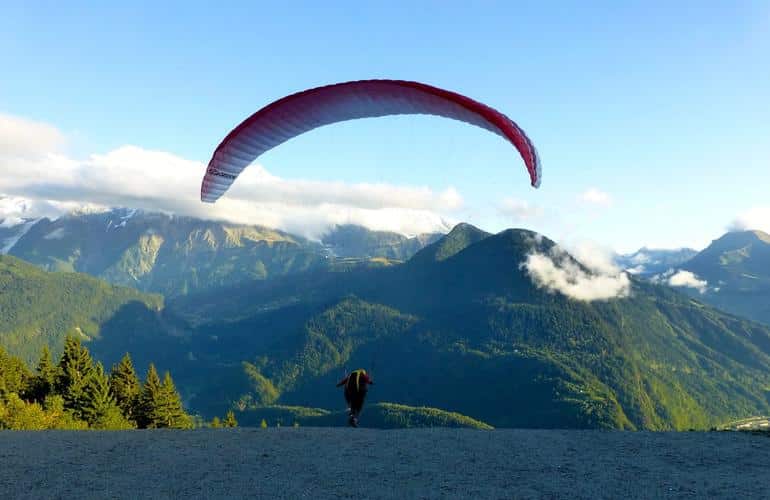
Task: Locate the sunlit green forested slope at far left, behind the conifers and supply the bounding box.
[0,256,188,368]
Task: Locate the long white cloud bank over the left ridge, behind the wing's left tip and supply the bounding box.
[0,118,463,237]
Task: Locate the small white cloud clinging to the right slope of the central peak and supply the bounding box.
[521,246,631,302]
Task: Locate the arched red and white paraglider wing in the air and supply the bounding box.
[201,80,540,203]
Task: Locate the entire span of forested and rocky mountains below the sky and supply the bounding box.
[0,205,770,429]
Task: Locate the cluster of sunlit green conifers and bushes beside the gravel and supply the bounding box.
[0,336,232,430]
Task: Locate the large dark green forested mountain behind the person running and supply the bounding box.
[171,226,770,429]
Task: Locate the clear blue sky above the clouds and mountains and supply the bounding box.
[0,2,770,251]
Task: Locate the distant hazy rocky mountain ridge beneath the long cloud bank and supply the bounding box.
[0,209,440,297]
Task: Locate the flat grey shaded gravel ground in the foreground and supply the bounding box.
[0,428,770,500]
